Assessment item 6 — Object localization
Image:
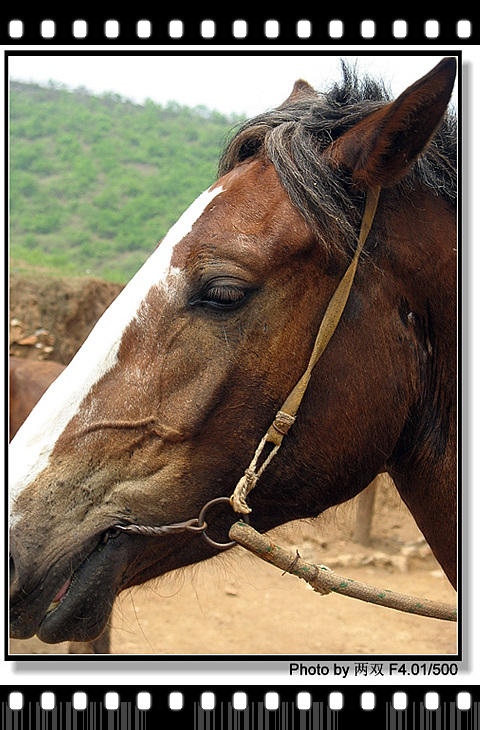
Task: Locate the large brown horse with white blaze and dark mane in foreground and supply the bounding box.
[9,58,457,643]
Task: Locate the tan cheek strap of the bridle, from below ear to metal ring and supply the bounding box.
[230,186,380,514]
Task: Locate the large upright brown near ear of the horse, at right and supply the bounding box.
[325,58,456,189]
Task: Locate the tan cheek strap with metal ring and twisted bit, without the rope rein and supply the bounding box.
[113,186,381,549]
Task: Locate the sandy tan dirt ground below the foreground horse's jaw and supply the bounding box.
[11,474,457,658]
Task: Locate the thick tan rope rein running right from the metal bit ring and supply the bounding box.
[229,522,457,621]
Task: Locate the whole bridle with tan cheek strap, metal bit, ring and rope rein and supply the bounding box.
[114,187,457,621]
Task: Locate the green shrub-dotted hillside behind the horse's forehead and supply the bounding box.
[10,82,244,282]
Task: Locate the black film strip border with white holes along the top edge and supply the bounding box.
[0,13,480,46]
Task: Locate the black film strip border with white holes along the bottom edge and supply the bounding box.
[0,686,480,730]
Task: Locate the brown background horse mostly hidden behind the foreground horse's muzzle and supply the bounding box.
[8,355,110,654]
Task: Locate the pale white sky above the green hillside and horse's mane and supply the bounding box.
[8,52,458,116]
